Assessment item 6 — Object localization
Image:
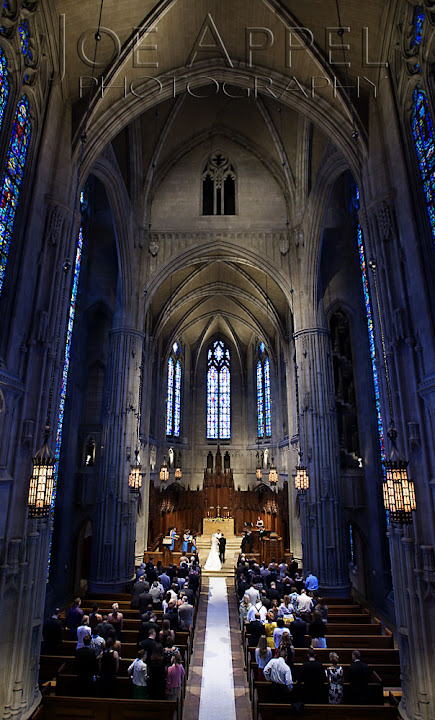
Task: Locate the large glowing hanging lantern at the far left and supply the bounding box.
[28,428,56,518]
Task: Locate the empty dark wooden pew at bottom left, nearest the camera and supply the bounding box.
[38,695,181,720]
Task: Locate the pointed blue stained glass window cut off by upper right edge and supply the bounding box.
[411,86,435,245]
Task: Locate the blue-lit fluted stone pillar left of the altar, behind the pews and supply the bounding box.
[89,328,143,593]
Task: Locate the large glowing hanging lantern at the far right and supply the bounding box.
[383,428,417,525]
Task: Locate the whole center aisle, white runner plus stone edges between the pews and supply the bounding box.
[184,577,251,720]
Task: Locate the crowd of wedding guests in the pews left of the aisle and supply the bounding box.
[41,552,199,700]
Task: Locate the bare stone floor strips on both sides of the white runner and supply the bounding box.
[184,576,252,720]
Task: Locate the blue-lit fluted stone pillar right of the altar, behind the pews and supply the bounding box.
[294,327,350,595]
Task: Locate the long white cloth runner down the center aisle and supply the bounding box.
[199,577,236,720]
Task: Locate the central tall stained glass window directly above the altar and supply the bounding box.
[207,340,231,440]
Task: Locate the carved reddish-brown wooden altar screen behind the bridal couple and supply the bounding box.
[148,448,289,551]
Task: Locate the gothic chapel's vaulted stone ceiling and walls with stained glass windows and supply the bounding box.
[0,0,435,720]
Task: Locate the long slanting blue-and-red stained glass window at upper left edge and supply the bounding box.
[0,95,31,294]
